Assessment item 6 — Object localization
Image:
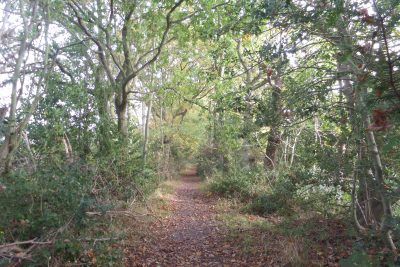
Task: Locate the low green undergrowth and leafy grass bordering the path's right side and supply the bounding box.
[206,164,397,266]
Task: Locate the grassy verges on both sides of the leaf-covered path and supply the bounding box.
[122,172,352,266]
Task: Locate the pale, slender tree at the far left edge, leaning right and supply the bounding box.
[0,0,51,172]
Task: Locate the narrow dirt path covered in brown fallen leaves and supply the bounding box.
[126,171,265,266]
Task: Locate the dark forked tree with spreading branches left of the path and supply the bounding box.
[63,0,184,137]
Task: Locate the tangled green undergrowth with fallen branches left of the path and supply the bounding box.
[0,150,161,266]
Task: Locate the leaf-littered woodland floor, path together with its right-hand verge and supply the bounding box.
[125,170,354,266]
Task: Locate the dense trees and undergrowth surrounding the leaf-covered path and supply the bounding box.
[0,0,400,266]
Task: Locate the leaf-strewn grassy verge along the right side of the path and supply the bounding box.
[212,195,354,266]
